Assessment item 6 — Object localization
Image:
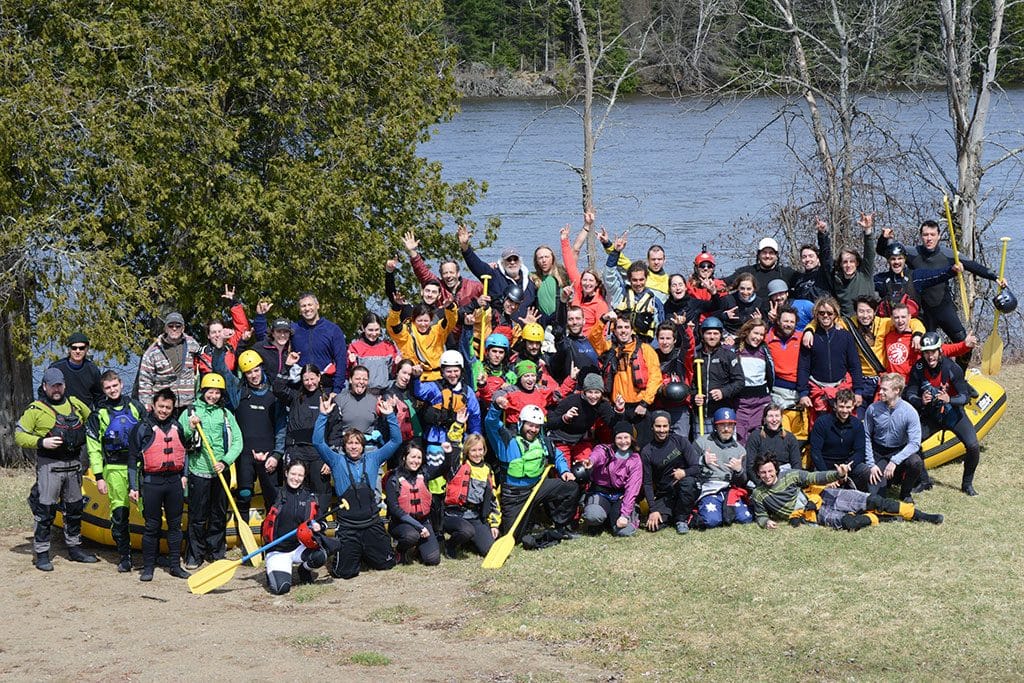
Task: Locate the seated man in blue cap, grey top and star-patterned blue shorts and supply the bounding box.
[693,408,754,528]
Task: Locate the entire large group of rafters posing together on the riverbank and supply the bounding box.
[15,214,1005,594]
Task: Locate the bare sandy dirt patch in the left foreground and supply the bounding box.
[0,529,609,681]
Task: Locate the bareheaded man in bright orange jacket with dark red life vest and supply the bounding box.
[590,311,662,445]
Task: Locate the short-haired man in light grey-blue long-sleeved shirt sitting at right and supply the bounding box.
[864,373,925,503]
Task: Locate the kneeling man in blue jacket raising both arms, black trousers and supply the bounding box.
[312,396,401,579]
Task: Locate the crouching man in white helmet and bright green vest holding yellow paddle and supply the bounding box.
[484,403,580,540]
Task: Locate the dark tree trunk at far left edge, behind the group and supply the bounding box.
[0,282,33,467]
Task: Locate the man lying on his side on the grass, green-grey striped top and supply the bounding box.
[751,454,943,531]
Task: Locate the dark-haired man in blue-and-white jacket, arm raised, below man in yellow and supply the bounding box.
[595,228,668,348]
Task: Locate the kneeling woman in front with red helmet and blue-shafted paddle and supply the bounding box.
[260,460,327,595]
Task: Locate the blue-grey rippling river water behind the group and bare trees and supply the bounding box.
[421,90,1024,280]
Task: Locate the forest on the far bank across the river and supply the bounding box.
[443,0,1024,93]
